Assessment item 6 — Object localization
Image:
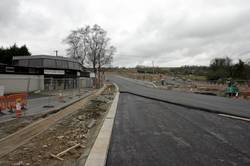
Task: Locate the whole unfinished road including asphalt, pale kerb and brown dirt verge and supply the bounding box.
[0,75,250,166]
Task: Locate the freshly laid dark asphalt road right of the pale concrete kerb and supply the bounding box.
[107,77,250,166]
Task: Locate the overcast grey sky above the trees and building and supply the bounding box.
[0,0,250,67]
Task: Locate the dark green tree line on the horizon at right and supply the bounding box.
[135,57,250,82]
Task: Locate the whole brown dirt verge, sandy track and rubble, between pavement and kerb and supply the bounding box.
[0,84,116,166]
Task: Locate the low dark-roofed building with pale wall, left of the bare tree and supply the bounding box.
[0,55,92,93]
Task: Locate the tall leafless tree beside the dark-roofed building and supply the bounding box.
[64,25,116,87]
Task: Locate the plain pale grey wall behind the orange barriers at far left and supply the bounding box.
[0,74,44,94]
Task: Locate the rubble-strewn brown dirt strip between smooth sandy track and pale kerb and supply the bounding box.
[0,85,115,166]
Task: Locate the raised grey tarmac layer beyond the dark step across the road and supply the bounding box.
[108,76,250,118]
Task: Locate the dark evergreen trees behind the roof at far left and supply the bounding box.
[0,44,31,65]
